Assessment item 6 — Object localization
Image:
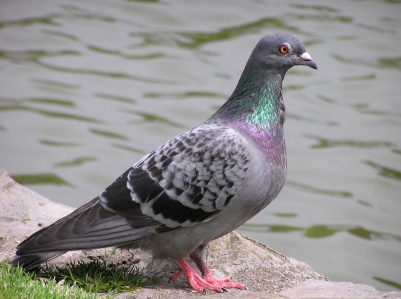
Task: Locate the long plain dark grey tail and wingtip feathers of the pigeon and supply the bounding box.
[11,198,166,269]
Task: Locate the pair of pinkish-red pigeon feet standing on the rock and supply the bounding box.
[170,259,246,294]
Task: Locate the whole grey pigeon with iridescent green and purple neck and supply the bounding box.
[11,33,317,293]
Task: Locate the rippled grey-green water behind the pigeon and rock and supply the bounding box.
[0,0,401,290]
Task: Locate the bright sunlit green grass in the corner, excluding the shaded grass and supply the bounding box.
[0,263,99,299]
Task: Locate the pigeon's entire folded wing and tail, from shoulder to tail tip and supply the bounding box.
[17,125,249,256]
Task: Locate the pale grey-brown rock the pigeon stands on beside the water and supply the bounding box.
[0,170,401,299]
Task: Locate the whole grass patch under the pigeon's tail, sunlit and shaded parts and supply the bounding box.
[0,249,157,299]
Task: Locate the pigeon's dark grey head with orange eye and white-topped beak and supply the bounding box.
[251,33,317,74]
